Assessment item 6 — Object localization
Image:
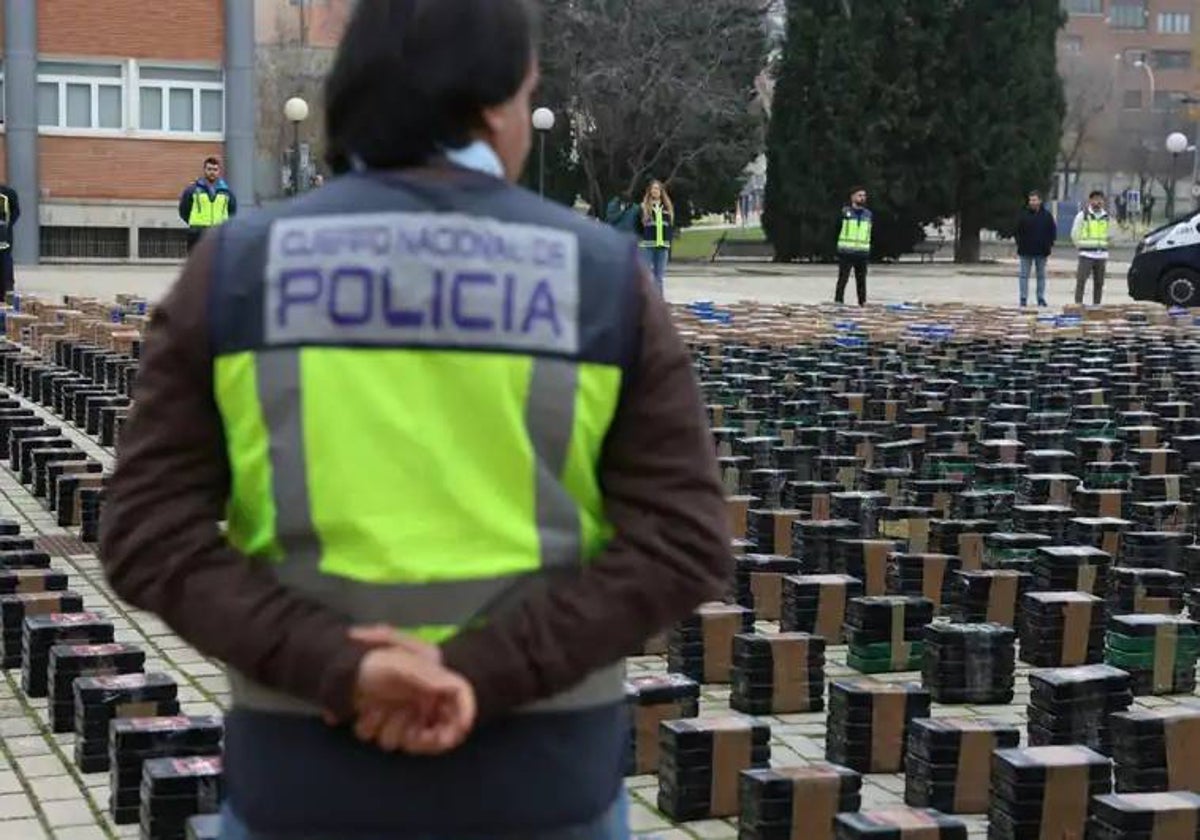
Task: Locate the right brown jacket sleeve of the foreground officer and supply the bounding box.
[443,271,733,720]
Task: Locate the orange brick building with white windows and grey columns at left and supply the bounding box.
[0,0,354,263]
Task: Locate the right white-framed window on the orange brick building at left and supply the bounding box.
[138,66,224,134]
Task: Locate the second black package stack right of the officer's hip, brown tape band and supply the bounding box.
[658,715,770,822]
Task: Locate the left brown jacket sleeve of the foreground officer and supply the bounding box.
[101,236,361,714]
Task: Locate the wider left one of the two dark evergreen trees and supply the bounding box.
[763,0,952,259]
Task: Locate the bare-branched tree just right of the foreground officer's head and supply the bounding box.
[539,0,767,211]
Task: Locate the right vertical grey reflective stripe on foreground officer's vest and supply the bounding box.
[526,359,583,569]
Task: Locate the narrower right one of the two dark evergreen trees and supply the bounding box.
[942,0,1066,263]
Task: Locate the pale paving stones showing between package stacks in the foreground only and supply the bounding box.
[0,343,1200,840]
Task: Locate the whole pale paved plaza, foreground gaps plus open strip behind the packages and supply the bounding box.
[0,262,1171,840]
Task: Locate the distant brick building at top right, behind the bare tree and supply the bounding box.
[1058,0,1200,206]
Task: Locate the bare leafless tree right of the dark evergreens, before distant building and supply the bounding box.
[1058,54,1115,198]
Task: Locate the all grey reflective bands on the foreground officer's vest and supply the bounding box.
[229,349,609,714]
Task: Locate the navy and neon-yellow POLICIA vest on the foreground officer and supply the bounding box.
[211,181,636,712]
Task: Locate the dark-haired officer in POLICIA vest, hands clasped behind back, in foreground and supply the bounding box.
[102,0,731,840]
